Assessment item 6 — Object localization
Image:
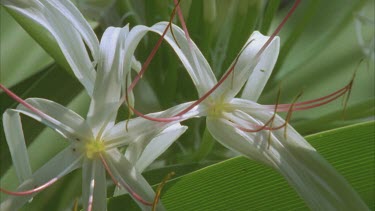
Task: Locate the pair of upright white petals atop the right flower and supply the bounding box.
[213,31,280,100]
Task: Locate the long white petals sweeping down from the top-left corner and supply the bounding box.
[1,0,99,96]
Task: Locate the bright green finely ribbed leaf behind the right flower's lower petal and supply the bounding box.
[108,121,375,211]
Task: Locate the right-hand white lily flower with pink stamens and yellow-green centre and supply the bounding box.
[129,23,368,210]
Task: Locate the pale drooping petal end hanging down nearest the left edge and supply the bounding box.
[3,109,32,183]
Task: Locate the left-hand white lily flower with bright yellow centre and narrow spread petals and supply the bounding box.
[0,27,186,210]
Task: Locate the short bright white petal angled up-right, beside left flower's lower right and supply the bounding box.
[135,123,187,172]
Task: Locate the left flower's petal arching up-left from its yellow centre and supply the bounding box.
[14,98,93,141]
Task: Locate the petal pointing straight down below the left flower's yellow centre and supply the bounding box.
[82,159,107,211]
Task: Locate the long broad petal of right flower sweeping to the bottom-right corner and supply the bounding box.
[207,105,367,210]
